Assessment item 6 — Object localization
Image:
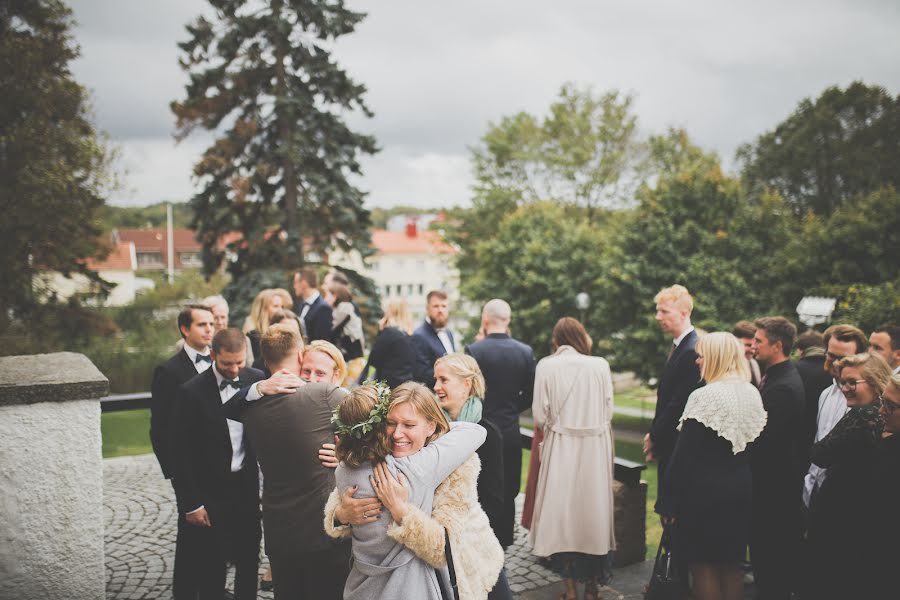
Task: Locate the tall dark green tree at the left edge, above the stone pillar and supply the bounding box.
[0,0,114,330]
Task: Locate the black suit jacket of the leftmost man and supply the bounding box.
[150,350,203,479]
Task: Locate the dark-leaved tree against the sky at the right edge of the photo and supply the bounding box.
[738,82,900,217]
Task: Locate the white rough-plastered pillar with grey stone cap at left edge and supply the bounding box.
[0,352,109,600]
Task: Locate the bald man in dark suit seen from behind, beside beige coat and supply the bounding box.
[466,298,535,548]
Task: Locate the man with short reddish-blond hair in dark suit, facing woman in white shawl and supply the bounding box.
[644,285,701,510]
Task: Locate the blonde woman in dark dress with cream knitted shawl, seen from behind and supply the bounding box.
[657,332,766,600]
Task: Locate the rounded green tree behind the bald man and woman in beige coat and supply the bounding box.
[461,202,605,356]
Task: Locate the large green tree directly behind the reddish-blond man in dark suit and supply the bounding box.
[600,131,792,379]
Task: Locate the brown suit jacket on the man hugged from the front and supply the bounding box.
[240,383,347,560]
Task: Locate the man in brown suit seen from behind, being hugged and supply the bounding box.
[227,325,350,600]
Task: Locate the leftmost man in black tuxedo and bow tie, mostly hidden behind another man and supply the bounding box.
[150,304,215,598]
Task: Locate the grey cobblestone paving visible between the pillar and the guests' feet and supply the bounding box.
[103,454,649,600]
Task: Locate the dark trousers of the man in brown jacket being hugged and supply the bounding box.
[269,540,350,600]
